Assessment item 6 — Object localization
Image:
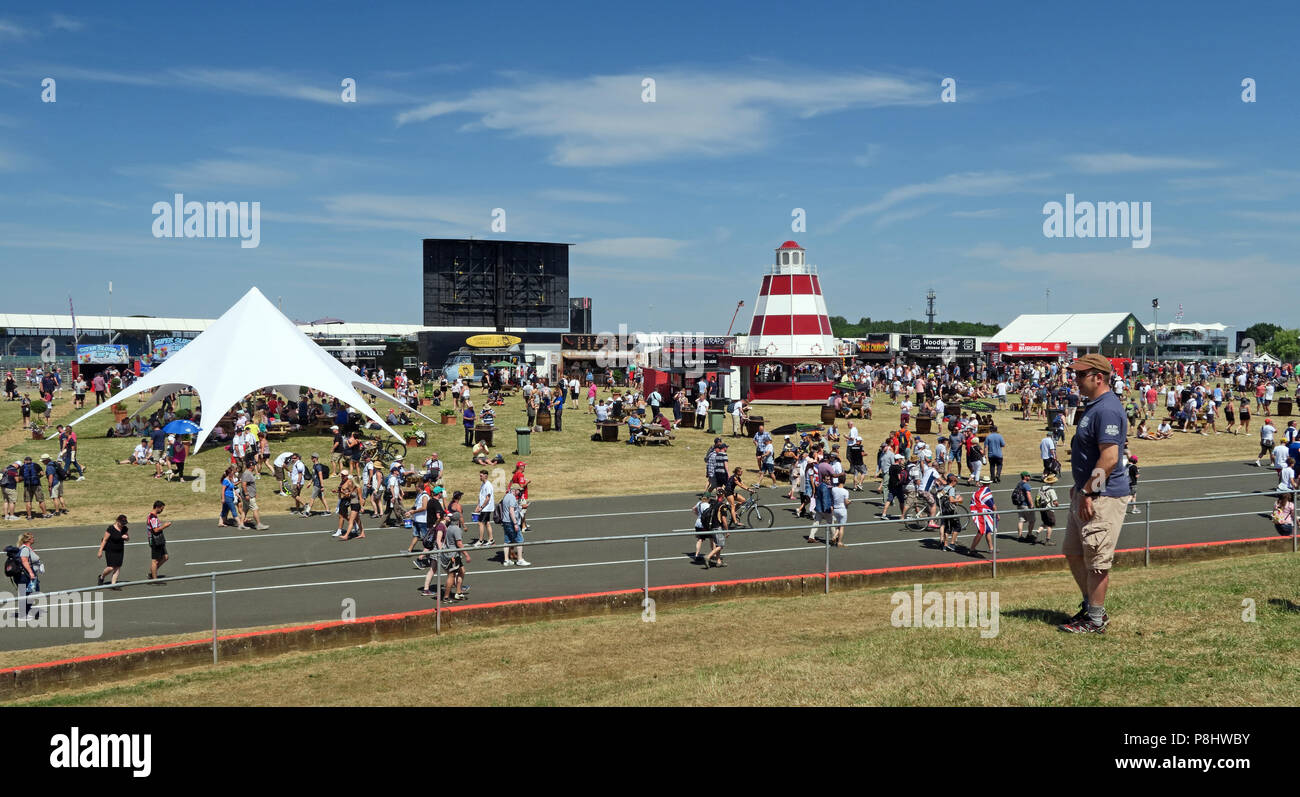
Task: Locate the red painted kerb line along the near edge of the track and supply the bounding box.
[0,536,1282,675]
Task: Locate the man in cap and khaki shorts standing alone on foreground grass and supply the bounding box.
[1060,354,1130,633]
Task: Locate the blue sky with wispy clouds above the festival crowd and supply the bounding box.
[0,3,1300,334]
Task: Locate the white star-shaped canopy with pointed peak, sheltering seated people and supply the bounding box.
[73,287,433,450]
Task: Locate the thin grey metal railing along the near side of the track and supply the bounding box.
[0,490,1300,663]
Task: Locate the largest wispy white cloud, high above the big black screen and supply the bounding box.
[397,70,939,166]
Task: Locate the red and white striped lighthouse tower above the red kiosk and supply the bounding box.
[749,241,836,358]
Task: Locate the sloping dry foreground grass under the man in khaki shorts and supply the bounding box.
[25,554,1300,706]
